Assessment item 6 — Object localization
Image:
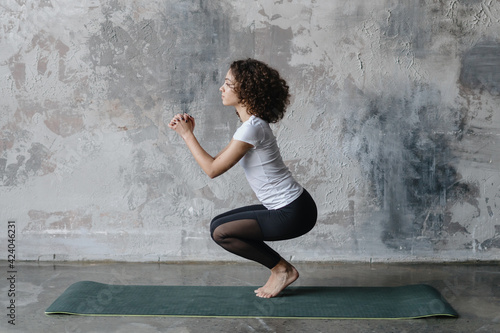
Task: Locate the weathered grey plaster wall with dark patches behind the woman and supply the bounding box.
[0,0,500,261]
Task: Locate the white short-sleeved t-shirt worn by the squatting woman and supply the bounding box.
[233,116,303,209]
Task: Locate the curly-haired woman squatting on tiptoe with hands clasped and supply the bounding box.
[169,59,317,298]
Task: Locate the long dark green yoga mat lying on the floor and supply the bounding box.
[45,281,458,319]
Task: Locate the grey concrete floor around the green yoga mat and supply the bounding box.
[0,262,500,333]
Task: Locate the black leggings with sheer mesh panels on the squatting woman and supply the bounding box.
[210,190,318,268]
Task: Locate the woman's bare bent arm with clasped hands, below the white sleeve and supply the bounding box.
[168,115,253,178]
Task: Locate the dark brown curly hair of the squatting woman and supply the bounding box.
[229,58,290,123]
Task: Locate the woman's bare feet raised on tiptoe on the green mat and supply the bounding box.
[255,259,299,298]
